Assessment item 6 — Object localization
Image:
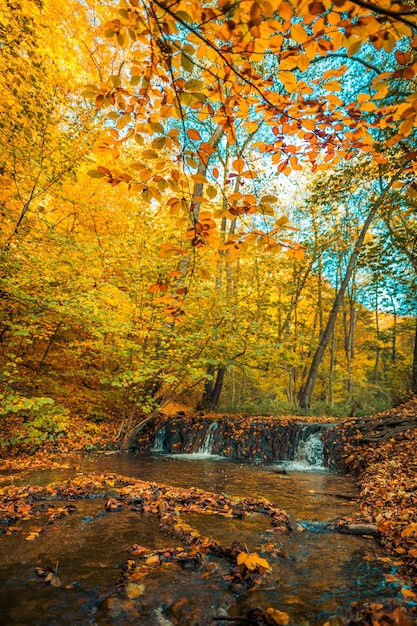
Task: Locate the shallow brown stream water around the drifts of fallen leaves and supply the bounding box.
[0,448,410,626]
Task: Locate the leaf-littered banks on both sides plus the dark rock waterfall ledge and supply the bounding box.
[0,398,417,601]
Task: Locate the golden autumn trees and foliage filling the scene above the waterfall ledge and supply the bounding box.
[0,0,417,438]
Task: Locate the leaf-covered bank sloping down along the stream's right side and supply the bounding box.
[342,398,417,588]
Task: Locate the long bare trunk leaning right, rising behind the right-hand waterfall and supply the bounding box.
[300,173,394,409]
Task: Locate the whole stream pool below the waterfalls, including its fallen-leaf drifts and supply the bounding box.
[0,453,414,626]
